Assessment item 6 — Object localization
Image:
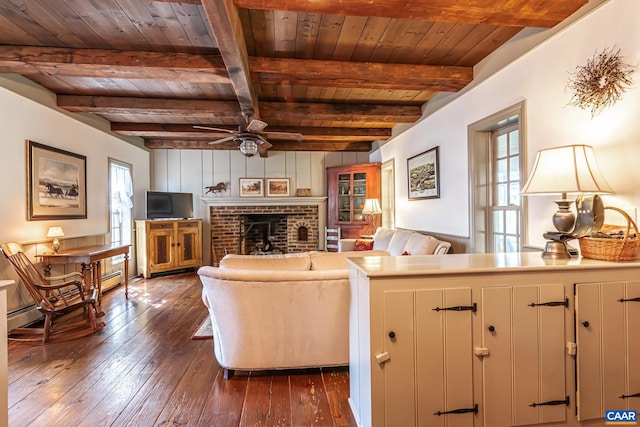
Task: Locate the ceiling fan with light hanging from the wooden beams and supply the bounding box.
[193,119,302,157]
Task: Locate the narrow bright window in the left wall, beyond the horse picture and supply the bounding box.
[109,159,133,264]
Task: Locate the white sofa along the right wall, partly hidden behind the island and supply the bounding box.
[338,227,451,256]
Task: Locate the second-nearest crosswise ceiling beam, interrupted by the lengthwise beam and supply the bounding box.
[0,46,473,91]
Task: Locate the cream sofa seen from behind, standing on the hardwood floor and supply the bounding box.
[198,250,389,378]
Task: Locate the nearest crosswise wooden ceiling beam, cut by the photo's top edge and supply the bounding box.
[234,0,588,28]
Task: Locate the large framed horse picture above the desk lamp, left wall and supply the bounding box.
[27,140,87,221]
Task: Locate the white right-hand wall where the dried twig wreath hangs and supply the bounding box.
[371,0,640,246]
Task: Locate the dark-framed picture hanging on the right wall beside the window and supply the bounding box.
[407,147,440,200]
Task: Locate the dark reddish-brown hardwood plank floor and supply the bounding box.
[9,273,355,427]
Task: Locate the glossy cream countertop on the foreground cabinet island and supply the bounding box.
[348,252,640,277]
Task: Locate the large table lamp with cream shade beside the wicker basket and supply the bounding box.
[521,145,613,259]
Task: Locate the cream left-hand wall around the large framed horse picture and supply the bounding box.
[0,75,150,310]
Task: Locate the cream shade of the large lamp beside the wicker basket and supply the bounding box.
[521,145,613,195]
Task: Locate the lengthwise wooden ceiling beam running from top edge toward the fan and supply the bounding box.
[202,0,260,119]
